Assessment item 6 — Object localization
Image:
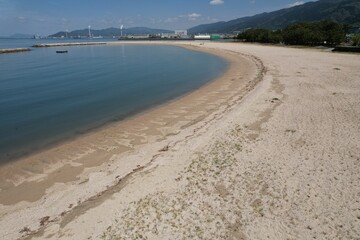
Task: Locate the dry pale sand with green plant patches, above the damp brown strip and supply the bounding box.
[0,42,360,239]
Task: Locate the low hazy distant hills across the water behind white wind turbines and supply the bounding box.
[49,27,173,37]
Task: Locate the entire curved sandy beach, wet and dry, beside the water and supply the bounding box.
[0,42,360,239]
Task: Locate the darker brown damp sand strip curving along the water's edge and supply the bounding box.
[0,42,255,236]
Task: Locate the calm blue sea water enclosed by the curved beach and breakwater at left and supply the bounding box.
[0,39,227,163]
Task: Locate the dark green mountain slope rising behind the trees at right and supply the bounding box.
[188,0,360,34]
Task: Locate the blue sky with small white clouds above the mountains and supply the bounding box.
[0,0,309,36]
